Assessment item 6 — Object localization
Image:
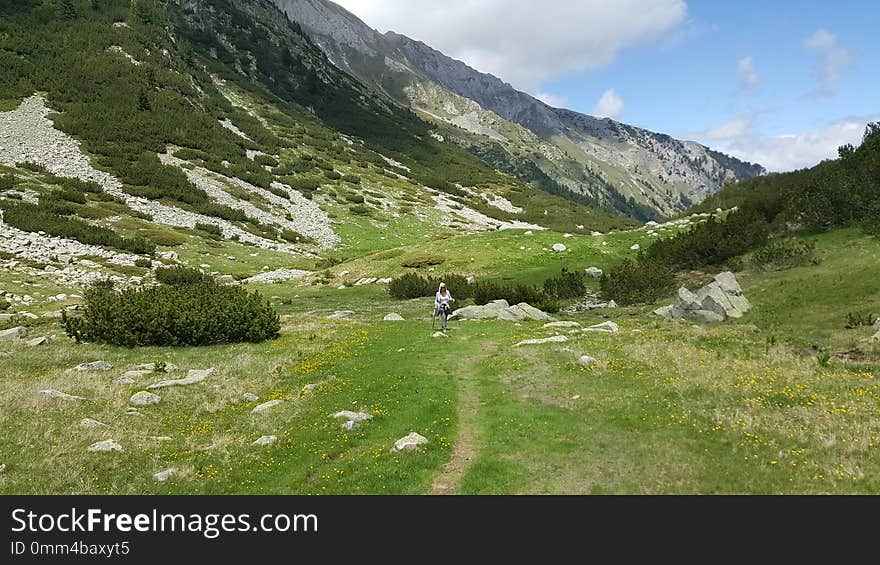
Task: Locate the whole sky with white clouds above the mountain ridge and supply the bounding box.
[336,0,880,171]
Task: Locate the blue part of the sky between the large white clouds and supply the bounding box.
[541,1,880,169]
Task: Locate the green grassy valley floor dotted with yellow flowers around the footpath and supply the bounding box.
[0,225,880,494]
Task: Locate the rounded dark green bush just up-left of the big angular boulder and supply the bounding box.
[599,255,675,306]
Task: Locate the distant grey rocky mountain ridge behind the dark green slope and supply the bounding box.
[274,0,766,219]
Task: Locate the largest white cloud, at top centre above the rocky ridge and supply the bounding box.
[337,0,687,92]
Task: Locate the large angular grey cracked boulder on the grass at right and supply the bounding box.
[654,272,752,324]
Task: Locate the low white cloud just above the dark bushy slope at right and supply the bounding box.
[716,115,880,171]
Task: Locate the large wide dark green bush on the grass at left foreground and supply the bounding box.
[62,282,281,347]
